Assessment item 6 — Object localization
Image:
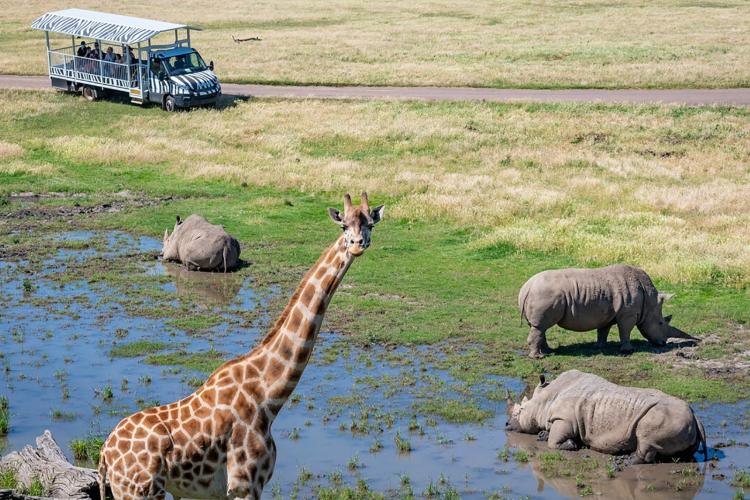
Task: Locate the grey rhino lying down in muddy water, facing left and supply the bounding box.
[505,370,708,463]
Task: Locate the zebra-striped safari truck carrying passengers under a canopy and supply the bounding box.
[31,9,221,111]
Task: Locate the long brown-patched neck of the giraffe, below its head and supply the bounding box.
[261,235,354,416]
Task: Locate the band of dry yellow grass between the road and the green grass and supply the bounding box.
[0,92,750,284]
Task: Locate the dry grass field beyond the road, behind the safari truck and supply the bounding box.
[0,0,750,88]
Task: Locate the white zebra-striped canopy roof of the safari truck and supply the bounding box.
[31,9,197,44]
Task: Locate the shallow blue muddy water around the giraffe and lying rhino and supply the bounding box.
[0,232,750,498]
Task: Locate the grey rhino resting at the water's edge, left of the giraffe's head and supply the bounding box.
[162,214,240,272]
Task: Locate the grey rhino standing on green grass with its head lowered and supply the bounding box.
[518,264,698,358]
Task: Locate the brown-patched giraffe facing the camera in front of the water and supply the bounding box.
[99,193,384,500]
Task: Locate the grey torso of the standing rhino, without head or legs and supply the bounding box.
[519,264,655,331]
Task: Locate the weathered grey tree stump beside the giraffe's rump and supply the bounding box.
[0,430,99,500]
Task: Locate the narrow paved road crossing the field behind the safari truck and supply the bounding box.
[0,75,750,106]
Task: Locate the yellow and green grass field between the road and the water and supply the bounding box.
[0,91,750,400]
